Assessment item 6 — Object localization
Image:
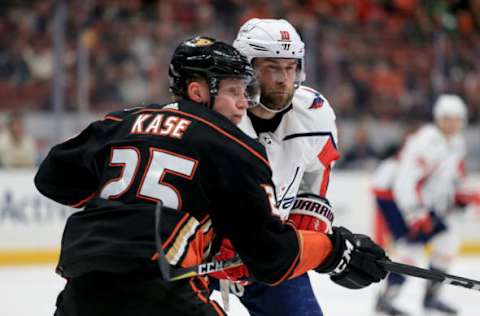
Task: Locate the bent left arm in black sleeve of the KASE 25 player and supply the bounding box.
[34,122,106,207]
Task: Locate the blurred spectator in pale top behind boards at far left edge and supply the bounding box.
[0,112,37,168]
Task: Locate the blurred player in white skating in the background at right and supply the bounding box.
[374,94,467,315]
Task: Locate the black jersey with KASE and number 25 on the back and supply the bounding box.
[35,101,300,283]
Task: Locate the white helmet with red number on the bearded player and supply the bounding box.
[233,18,306,84]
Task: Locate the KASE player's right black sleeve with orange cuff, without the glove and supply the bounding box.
[199,143,331,284]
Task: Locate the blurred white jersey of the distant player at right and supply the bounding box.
[374,124,465,214]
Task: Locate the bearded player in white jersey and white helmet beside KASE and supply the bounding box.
[210,19,339,316]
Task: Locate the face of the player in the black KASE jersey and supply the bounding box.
[213,78,248,124]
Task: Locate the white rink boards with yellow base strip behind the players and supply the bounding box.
[0,170,480,265]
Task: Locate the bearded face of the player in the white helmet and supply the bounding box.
[253,58,298,110]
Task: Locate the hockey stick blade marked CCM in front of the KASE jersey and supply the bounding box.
[155,202,243,281]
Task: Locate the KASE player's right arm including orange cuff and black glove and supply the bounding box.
[206,147,385,286]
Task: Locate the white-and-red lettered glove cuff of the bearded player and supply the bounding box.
[288,193,335,233]
